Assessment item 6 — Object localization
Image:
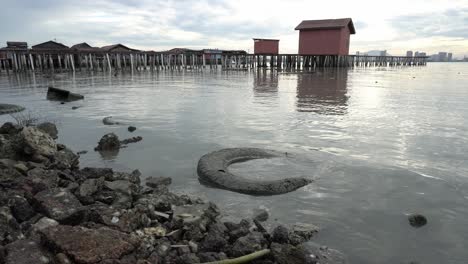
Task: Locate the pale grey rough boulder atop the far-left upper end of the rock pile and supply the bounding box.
[20,127,57,158]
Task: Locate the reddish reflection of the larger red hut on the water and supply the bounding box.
[297,69,349,115]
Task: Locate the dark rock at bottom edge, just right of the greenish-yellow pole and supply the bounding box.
[270,243,316,264]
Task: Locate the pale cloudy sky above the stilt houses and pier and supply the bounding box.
[0,0,468,58]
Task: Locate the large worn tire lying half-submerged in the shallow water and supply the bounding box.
[197,148,312,195]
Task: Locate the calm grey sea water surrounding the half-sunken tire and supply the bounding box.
[0,63,468,264]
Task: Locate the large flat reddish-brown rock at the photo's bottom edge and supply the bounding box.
[42,225,137,264]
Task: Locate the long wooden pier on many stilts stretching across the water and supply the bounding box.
[0,50,427,73]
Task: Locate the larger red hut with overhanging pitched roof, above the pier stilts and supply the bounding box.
[295,18,356,55]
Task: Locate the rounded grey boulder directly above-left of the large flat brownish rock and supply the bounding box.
[34,188,85,224]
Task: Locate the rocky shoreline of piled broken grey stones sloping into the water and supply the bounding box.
[0,123,345,264]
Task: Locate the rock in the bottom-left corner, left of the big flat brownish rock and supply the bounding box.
[5,240,54,264]
